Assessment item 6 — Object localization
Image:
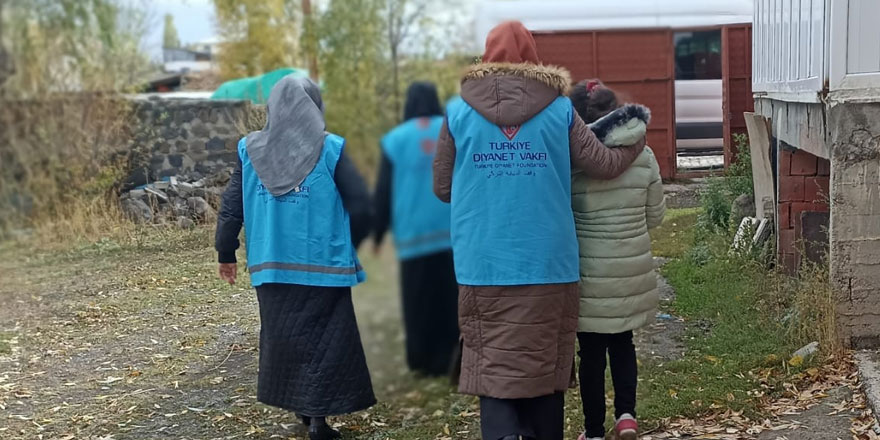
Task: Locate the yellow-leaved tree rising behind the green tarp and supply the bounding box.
[213,0,300,79]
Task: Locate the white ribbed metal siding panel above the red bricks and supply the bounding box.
[752,0,824,100]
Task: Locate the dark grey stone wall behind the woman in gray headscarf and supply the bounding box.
[126,97,265,187]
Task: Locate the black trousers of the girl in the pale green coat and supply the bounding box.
[578,331,638,437]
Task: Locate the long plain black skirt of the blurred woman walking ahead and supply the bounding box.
[400,251,458,376]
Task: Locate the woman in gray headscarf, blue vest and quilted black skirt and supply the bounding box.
[216,76,376,440]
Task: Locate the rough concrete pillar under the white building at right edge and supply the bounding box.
[828,103,880,348]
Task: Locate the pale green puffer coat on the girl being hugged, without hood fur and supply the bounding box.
[571,148,666,333]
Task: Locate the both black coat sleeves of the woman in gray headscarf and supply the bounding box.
[220,154,372,263]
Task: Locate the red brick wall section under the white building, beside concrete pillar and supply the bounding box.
[778,150,831,273]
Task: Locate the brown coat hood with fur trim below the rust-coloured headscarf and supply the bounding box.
[461,63,571,125]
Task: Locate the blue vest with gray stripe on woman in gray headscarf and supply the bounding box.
[238,134,366,287]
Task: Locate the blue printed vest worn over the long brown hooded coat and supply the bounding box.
[447,97,579,286]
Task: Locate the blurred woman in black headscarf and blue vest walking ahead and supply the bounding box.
[374,82,458,376]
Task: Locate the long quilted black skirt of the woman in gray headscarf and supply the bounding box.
[257,284,376,417]
